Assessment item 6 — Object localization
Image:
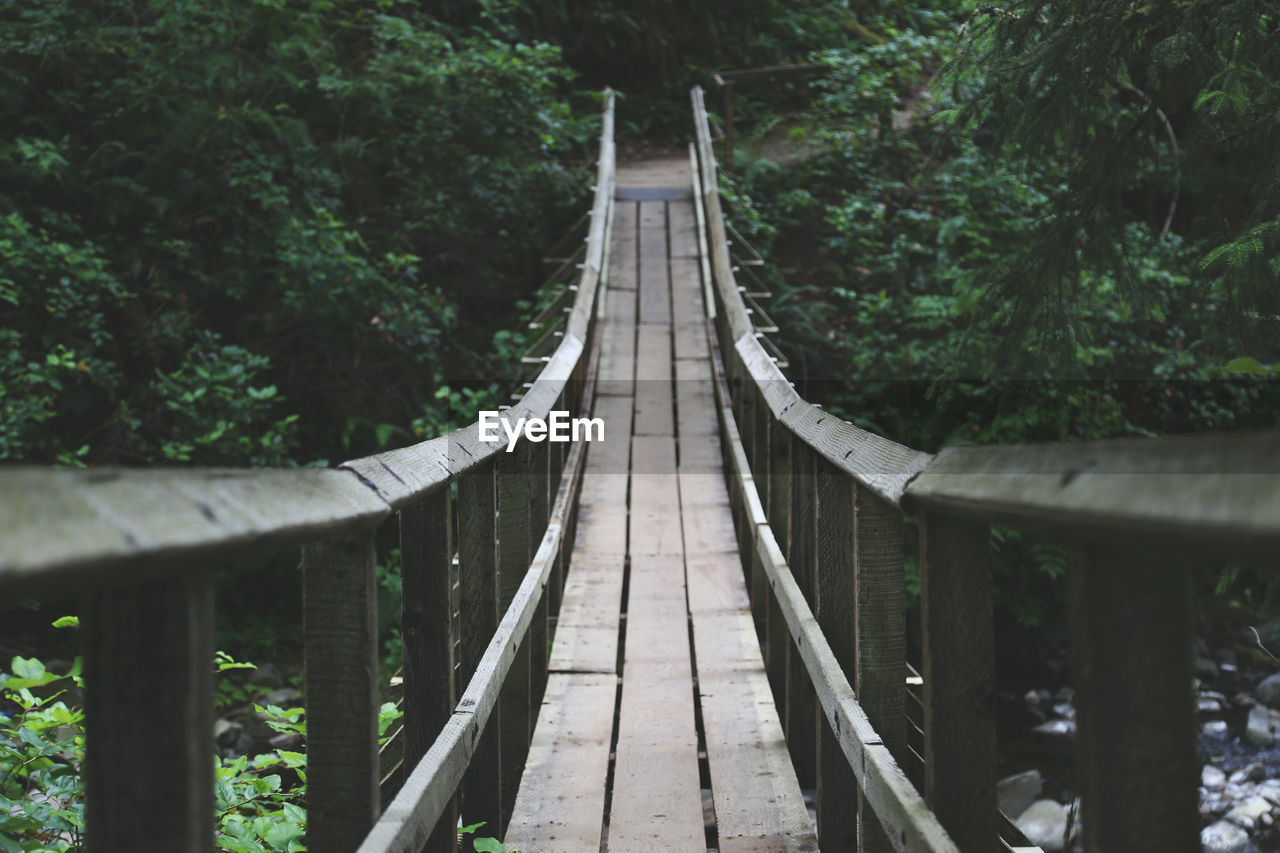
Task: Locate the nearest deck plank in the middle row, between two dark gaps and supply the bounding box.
[609,556,707,853]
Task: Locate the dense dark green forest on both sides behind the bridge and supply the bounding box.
[0,0,1280,849]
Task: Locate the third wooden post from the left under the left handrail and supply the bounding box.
[399,484,458,853]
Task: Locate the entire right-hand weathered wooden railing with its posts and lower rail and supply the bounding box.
[692,90,1280,853]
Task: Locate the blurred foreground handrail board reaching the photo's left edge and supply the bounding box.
[0,467,390,597]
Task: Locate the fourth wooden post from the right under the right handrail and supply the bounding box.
[814,459,858,850]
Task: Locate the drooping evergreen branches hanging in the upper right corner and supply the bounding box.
[946,0,1280,361]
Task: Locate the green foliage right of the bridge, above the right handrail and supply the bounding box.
[724,3,1280,637]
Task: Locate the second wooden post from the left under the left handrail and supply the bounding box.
[302,532,379,853]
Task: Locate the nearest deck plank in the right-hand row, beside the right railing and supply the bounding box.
[690,612,818,852]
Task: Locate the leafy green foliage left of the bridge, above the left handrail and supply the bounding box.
[0,0,593,465]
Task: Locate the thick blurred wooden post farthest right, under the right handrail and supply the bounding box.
[1069,542,1201,853]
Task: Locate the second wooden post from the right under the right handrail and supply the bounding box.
[920,512,997,850]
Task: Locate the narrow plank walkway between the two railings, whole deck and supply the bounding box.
[506,160,818,853]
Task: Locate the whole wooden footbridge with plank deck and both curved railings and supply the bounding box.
[0,90,1280,853]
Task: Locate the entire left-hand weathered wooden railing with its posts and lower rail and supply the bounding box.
[0,95,614,853]
